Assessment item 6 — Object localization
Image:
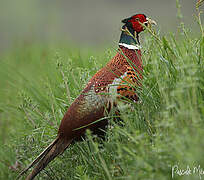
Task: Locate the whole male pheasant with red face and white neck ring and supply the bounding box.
[20,14,155,180]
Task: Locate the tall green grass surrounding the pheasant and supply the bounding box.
[0,17,204,180]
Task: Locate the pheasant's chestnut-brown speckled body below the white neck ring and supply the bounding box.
[58,46,142,140]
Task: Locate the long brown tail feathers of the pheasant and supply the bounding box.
[18,137,72,180]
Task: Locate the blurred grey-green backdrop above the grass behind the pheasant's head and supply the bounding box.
[0,0,201,52]
